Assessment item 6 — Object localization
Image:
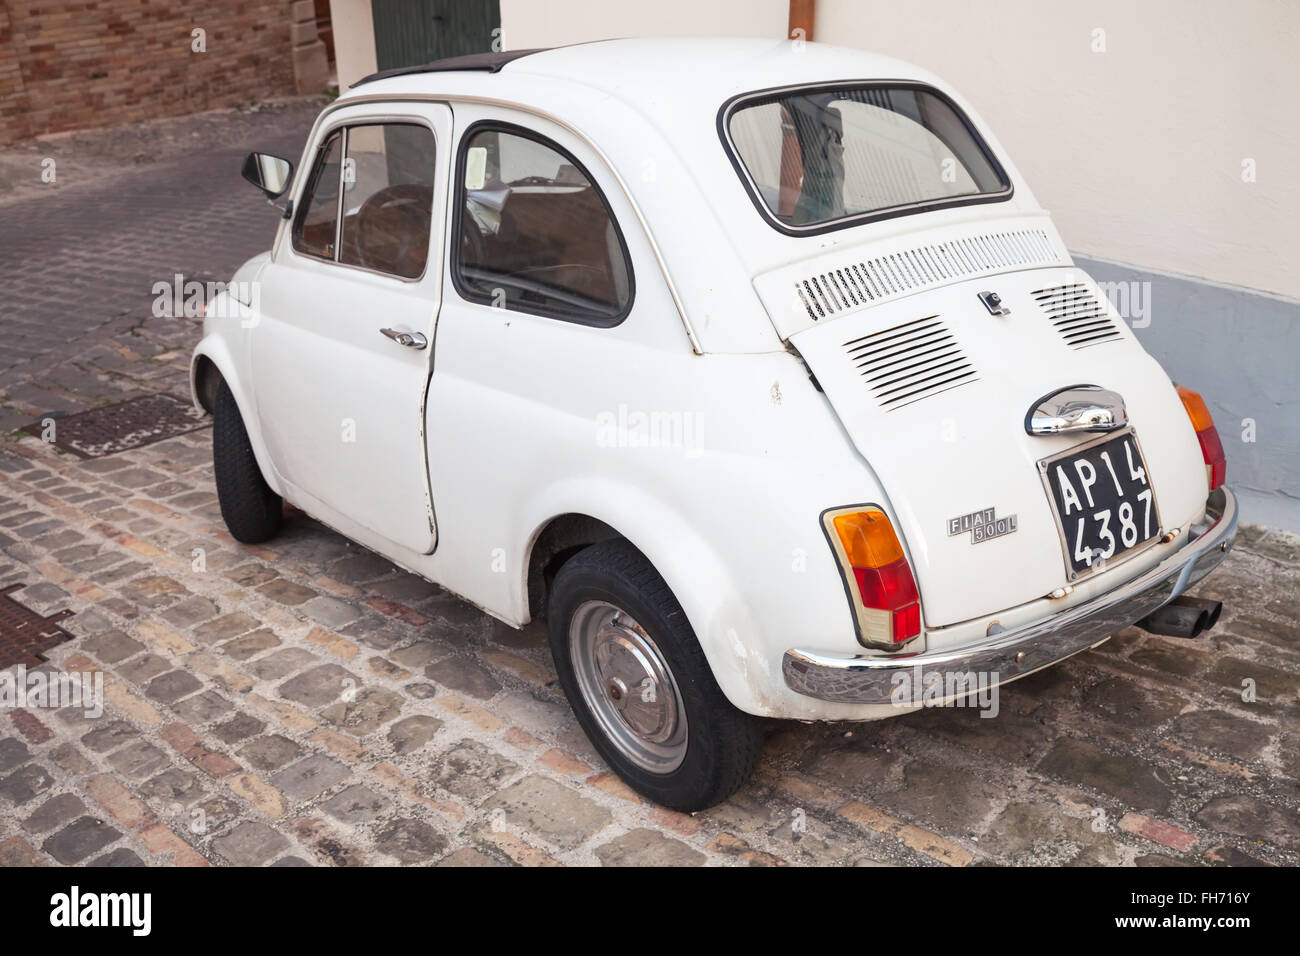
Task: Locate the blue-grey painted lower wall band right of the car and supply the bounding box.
[1074,256,1300,532]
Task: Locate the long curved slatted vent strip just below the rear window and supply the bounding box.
[794,229,1067,321]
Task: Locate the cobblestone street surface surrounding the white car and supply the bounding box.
[0,103,1300,866]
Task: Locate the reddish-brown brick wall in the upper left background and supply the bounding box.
[0,0,294,143]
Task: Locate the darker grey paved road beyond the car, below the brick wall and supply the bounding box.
[0,98,322,392]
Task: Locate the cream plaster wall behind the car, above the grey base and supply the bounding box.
[499,0,1300,298]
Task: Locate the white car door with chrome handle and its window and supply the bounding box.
[250,104,451,554]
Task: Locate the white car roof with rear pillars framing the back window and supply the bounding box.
[338,36,1045,351]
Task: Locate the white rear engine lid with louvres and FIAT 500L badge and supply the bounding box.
[789,265,1206,627]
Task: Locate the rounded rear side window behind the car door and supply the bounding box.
[452,124,633,326]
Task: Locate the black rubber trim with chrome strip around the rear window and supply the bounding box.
[718,79,1015,235]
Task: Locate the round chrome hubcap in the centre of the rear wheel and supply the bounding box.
[569,601,686,774]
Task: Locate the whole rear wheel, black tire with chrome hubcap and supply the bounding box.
[549,541,763,812]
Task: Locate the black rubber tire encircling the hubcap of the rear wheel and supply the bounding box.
[547,541,763,812]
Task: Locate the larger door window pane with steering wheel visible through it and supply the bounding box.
[338,124,434,278]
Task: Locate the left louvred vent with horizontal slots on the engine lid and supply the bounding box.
[844,315,978,411]
